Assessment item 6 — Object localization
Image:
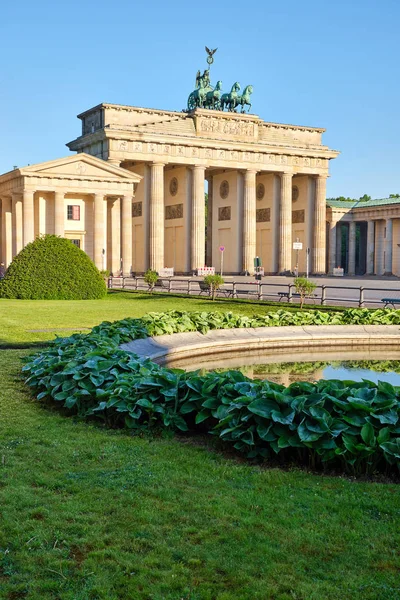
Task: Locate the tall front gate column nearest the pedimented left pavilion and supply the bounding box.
[149,163,164,272]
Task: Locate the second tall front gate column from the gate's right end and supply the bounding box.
[278,173,293,274]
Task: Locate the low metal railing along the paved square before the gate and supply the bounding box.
[108,276,400,308]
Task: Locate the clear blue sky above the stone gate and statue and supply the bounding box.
[0,0,400,198]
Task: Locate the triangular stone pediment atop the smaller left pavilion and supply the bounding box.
[20,153,141,183]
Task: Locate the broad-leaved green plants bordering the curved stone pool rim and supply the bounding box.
[23,309,400,475]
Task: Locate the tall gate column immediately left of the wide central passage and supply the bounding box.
[190,165,206,271]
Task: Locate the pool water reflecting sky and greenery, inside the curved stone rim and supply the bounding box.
[177,348,400,386]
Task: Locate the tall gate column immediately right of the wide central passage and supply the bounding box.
[242,170,257,275]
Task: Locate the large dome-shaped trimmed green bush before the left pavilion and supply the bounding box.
[0,235,107,300]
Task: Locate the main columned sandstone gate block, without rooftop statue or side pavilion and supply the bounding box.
[67,104,338,273]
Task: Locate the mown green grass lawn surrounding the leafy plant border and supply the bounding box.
[0,294,400,600]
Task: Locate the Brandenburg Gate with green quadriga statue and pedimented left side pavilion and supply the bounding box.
[0,48,338,274]
